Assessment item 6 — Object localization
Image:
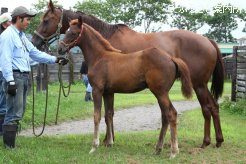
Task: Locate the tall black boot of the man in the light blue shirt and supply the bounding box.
[3,124,18,149]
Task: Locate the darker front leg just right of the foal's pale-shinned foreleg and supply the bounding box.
[103,94,114,146]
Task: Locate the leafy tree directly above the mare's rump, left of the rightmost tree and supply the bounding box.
[171,6,208,32]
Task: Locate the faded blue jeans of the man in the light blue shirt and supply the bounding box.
[4,72,29,125]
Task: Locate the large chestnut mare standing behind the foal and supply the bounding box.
[32,1,224,147]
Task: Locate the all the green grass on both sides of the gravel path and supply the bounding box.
[0,79,240,164]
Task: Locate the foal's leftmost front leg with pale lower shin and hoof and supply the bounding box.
[90,88,102,153]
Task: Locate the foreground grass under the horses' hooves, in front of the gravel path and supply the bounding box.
[0,102,246,164]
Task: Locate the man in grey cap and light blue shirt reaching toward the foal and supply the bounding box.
[0,6,68,148]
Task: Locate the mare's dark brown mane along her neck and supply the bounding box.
[76,11,129,39]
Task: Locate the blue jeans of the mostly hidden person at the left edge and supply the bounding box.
[0,71,7,116]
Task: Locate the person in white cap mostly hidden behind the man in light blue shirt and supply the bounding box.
[0,13,12,136]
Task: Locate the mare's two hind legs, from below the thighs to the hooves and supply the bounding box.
[194,85,224,148]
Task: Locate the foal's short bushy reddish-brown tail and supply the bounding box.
[172,57,192,98]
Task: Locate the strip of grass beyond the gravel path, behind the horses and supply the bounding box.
[22,81,231,129]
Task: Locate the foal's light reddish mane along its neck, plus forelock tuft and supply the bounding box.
[70,19,121,52]
